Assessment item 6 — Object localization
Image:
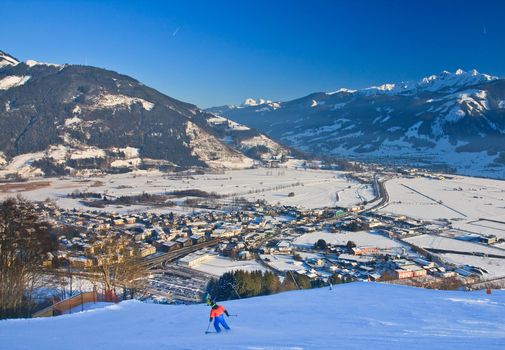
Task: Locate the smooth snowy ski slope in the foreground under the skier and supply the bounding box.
[0,283,505,350]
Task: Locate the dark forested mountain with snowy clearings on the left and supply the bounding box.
[0,51,289,178]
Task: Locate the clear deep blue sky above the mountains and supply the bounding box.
[0,0,505,107]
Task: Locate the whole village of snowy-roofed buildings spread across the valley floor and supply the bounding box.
[30,164,505,303]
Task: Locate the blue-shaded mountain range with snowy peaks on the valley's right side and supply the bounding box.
[209,69,505,178]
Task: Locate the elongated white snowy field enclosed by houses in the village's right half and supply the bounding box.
[293,231,401,249]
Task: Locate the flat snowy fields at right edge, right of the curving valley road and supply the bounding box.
[381,176,505,278]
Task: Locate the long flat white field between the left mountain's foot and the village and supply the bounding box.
[0,168,374,212]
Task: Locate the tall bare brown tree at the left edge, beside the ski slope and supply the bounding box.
[0,198,56,319]
